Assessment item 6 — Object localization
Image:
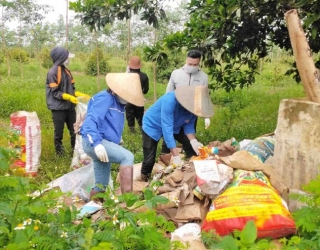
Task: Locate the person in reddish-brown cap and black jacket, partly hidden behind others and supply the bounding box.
[126,56,149,133]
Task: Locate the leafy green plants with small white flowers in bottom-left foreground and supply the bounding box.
[0,135,178,250]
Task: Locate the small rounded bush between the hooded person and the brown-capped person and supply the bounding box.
[85,49,110,76]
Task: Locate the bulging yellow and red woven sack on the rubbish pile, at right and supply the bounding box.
[202,170,296,238]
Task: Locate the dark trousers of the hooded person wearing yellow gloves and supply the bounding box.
[51,110,76,155]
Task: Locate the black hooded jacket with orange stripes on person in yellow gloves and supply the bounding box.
[46,47,76,110]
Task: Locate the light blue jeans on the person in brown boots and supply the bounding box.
[82,137,134,191]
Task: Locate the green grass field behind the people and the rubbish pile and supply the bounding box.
[0,55,305,185]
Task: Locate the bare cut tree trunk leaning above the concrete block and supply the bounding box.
[285,9,320,103]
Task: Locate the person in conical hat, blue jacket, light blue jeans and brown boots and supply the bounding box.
[80,73,144,199]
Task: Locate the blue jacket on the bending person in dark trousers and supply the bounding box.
[142,91,196,149]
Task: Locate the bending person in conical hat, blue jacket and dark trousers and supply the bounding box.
[141,86,213,181]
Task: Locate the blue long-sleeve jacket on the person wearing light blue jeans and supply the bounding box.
[80,90,125,147]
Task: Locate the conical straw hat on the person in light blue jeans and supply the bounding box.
[106,73,144,107]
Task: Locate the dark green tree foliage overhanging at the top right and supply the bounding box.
[159,0,320,91]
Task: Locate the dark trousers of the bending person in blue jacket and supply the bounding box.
[141,131,196,175]
